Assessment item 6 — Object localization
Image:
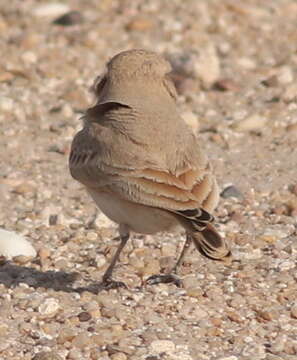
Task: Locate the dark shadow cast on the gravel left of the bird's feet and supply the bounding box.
[0,261,107,294]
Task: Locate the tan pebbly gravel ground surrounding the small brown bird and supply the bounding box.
[0,0,297,360]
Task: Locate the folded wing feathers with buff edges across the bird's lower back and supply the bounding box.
[69,131,216,212]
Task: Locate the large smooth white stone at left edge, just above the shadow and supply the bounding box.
[0,229,36,259]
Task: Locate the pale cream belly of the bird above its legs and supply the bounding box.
[87,188,181,234]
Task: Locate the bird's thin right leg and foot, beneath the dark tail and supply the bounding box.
[146,233,192,287]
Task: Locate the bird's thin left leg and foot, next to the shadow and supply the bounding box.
[102,224,130,289]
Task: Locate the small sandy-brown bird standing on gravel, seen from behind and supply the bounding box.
[69,49,232,289]
